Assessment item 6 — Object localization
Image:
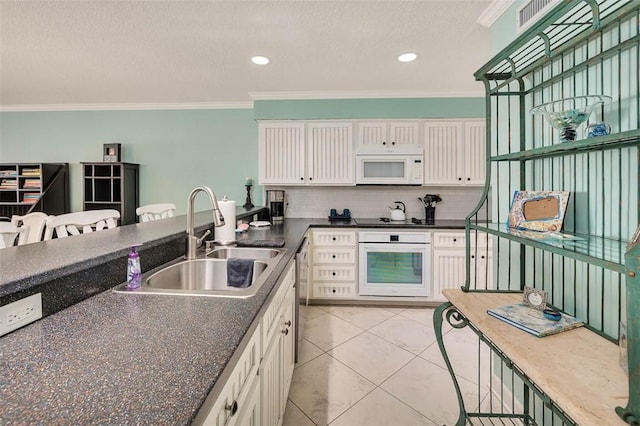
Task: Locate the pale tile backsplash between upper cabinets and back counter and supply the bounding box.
[266,186,484,219]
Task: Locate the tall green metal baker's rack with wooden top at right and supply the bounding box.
[434,0,640,425]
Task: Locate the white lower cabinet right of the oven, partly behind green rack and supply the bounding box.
[432,231,493,302]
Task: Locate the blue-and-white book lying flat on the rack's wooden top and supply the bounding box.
[487,303,584,337]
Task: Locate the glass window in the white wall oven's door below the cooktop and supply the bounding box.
[367,251,424,286]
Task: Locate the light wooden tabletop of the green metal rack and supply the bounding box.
[443,289,629,425]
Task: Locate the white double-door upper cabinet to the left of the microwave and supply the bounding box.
[258,122,355,185]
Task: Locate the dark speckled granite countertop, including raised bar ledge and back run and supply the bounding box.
[0,218,464,425]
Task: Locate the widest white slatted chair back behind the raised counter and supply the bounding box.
[44,209,120,241]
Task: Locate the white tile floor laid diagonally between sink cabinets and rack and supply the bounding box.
[283,306,484,426]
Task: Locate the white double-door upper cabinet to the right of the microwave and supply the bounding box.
[424,120,486,185]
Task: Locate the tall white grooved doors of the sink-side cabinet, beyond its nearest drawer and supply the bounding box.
[258,267,296,426]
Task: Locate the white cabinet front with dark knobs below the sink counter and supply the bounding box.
[203,262,296,426]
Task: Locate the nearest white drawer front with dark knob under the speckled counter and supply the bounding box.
[204,329,262,426]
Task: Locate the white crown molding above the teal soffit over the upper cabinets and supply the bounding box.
[249,89,485,101]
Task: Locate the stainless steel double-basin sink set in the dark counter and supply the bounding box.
[114,248,284,298]
